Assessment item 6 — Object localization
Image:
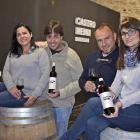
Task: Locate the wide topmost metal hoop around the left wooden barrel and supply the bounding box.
[0,105,53,117]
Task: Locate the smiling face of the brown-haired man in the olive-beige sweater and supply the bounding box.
[46,31,64,51]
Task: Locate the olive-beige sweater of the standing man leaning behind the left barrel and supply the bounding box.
[40,41,83,107]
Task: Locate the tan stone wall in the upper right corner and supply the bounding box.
[90,0,140,20]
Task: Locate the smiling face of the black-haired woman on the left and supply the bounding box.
[16,26,32,47]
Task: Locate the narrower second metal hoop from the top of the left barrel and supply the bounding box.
[0,113,54,124]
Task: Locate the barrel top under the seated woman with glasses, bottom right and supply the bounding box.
[100,127,140,140]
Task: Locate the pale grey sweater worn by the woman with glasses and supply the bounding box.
[111,64,140,108]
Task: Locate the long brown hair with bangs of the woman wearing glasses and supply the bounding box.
[117,17,140,70]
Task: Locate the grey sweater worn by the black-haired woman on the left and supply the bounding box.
[3,48,50,98]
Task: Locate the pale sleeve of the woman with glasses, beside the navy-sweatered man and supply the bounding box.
[111,70,122,97]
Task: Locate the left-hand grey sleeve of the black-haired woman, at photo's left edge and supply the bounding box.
[2,55,15,90]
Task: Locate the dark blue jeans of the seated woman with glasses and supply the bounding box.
[59,97,140,140]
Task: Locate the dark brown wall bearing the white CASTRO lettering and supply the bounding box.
[0,0,120,105]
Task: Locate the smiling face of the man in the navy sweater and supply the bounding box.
[95,26,116,56]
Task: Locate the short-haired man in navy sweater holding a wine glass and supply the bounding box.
[79,23,119,99]
